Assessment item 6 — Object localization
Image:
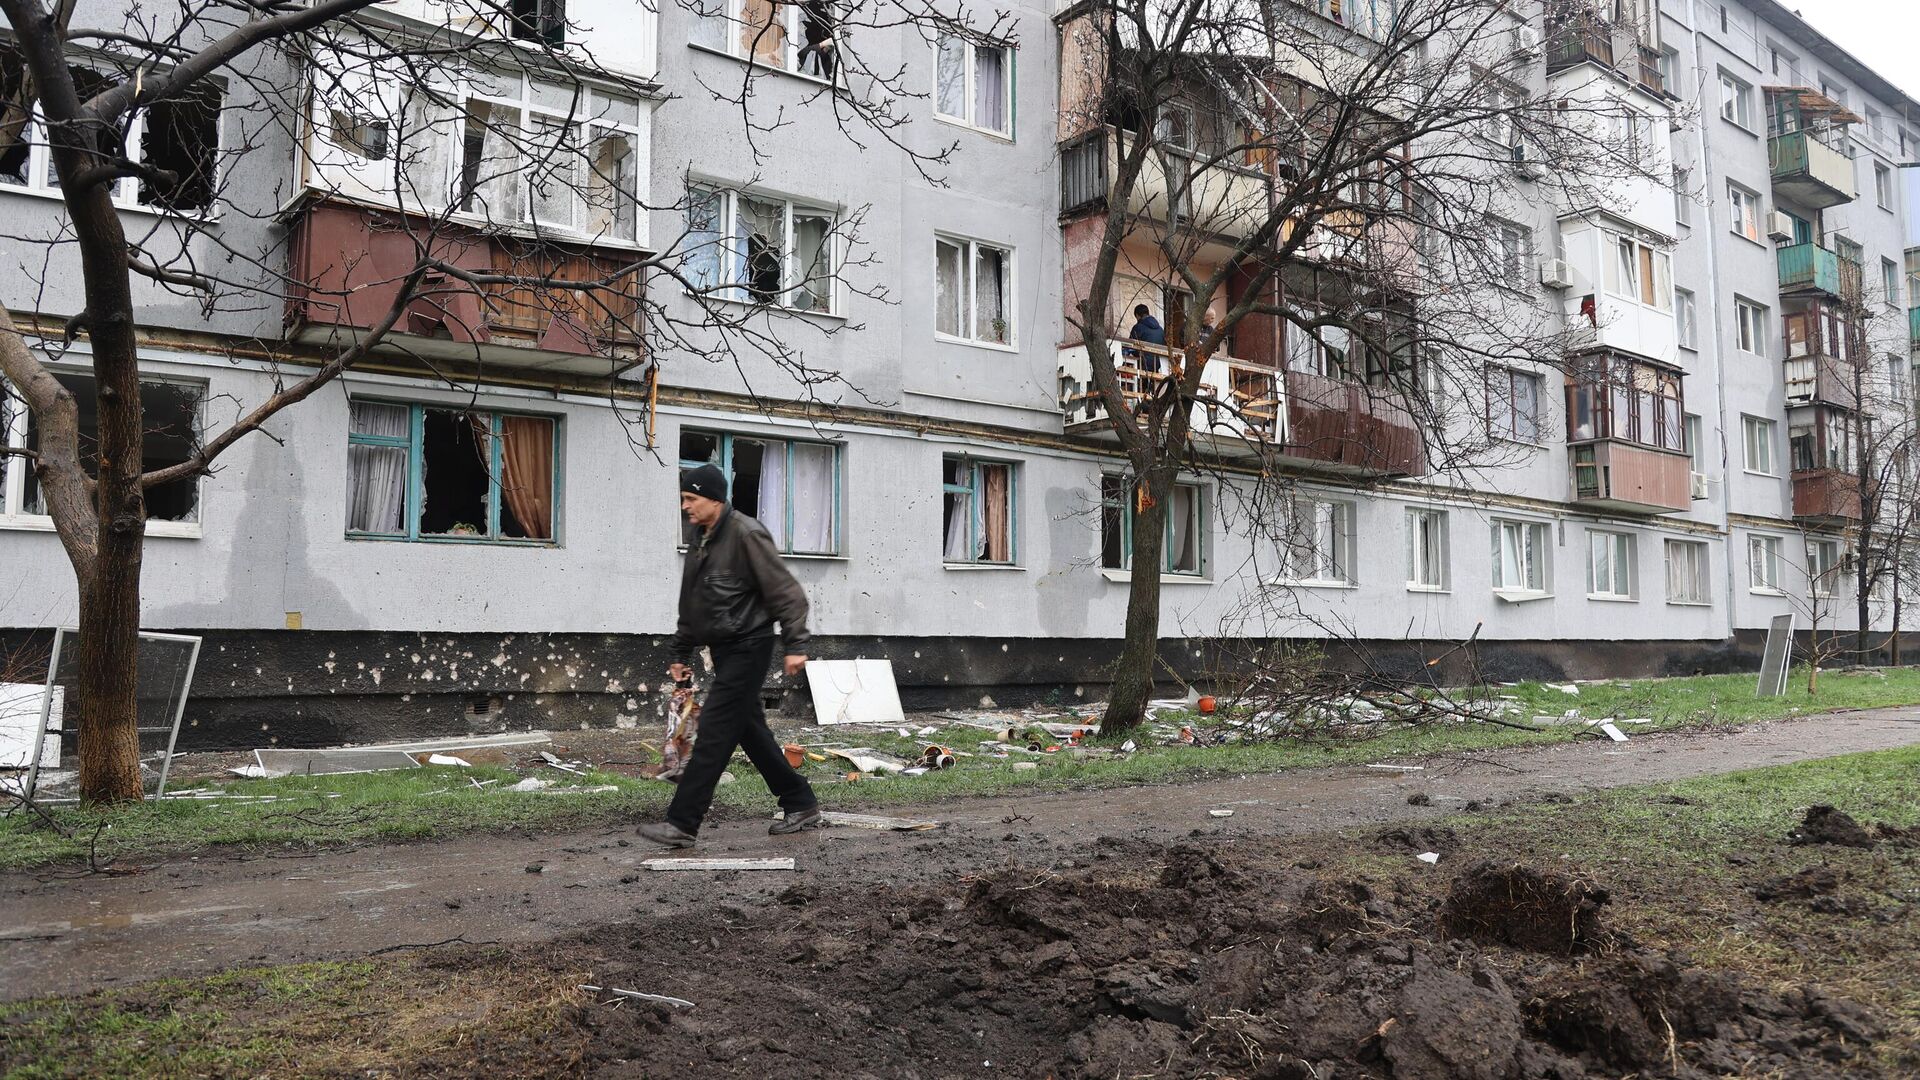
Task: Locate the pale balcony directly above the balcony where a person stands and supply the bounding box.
[1060,127,1271,236]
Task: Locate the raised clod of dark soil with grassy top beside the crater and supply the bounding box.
[1440,863,1607,957]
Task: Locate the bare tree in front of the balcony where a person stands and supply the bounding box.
[1062,0,1678,730]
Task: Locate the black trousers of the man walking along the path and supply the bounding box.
[666,634,818,832]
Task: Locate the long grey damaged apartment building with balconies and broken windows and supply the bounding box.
[0,0,1920,746]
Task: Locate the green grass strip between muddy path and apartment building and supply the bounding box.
[11,669,1920,869]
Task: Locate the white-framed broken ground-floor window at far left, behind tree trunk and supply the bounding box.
[0,371,205,523]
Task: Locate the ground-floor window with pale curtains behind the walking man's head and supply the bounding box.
[680,430,839,555]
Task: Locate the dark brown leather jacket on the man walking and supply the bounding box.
[674,505,806,663]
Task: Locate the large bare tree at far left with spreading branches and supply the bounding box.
[0,0,972,801]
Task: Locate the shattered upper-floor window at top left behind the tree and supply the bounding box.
[0,48,227,213]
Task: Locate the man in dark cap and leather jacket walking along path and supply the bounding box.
[639,465,826,847]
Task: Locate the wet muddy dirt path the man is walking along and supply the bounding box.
[0,709,1920,999]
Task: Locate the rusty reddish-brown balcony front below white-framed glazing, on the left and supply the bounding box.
[288,200,643,377]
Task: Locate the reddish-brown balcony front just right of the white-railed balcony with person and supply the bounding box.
[1281,371,1427,477]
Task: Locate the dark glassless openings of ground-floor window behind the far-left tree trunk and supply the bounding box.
[18,371,205,521]
